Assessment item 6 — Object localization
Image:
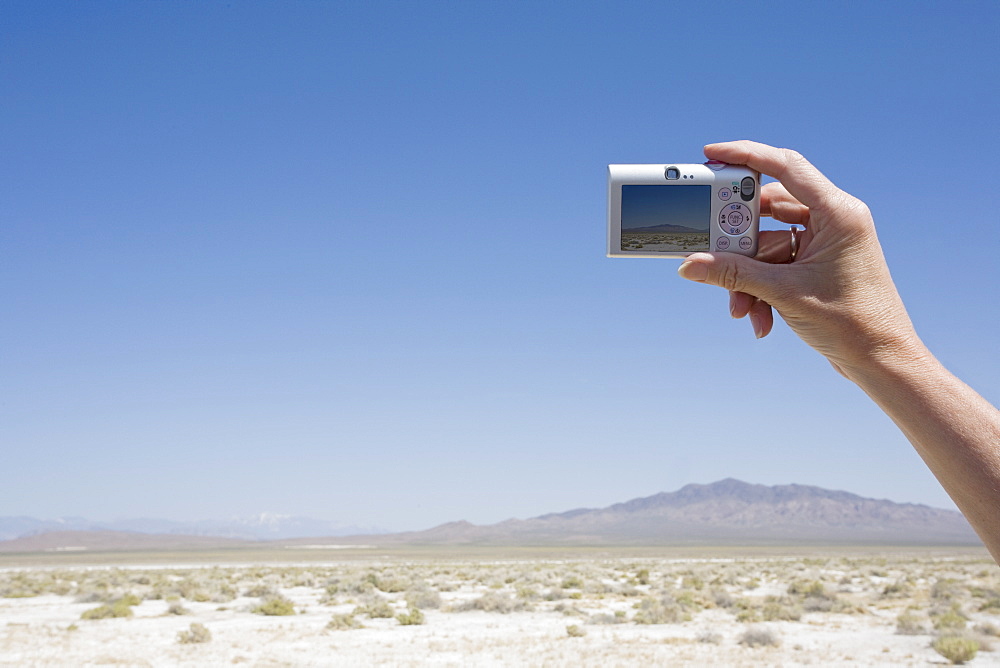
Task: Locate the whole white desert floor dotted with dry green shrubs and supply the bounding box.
[0,549,1000,667]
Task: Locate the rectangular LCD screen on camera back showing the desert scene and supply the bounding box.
[622,185,712,253]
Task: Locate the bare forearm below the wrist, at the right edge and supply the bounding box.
[844,337,1000,563]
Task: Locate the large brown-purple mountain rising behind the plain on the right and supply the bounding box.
[326,478,980,545]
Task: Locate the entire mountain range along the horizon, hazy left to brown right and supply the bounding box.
[0,478,981,552]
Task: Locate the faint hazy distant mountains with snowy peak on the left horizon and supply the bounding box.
[0,513,385,540]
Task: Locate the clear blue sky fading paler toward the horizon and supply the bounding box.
[0,0,1000,529]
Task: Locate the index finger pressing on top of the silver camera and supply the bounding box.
[705,139,837,208]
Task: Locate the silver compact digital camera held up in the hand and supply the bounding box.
[608,160,760,257]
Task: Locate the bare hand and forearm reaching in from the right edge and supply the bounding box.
[678,141,1000,563]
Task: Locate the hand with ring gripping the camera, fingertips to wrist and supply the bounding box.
[678,141,918,378]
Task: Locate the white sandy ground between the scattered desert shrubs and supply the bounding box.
[0,560,1000,667]
